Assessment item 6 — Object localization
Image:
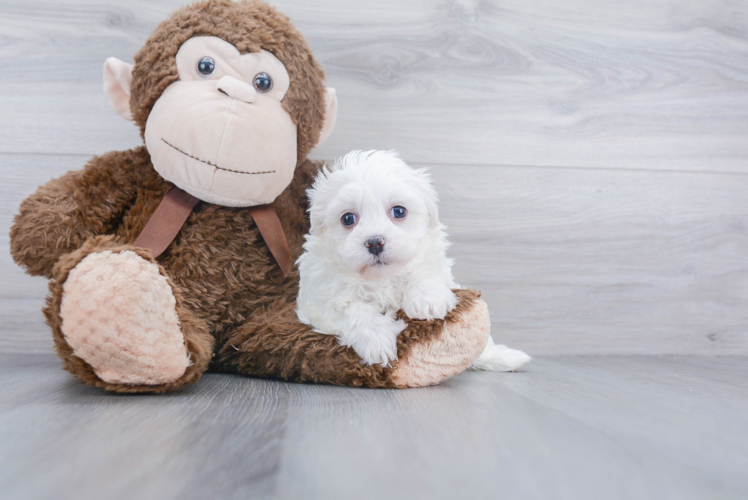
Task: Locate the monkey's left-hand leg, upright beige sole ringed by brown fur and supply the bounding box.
[44,236,213,392]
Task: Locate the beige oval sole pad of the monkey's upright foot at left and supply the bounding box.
[60,251,189,385]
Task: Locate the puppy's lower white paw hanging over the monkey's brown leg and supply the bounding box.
[347,315,407,366]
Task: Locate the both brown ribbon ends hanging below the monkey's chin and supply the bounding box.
[133,186,291,276]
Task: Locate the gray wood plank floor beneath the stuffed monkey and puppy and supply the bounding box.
[0,355,748,500]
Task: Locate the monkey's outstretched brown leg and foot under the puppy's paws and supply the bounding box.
[214,290,490,388]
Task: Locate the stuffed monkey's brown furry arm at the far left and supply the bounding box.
[10,148,152,278]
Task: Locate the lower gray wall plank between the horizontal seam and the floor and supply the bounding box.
[0,154,748,355]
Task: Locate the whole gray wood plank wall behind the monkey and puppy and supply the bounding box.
[0,0,748,355]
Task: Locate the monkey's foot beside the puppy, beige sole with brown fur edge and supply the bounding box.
[391,290,491,387]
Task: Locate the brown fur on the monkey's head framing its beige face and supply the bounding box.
[130,0,325,166]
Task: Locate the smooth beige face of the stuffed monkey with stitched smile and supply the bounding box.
[145,37,297,207]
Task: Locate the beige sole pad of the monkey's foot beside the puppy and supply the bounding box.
[392,300,491,387]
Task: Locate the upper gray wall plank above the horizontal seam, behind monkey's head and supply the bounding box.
[0,0,748,172]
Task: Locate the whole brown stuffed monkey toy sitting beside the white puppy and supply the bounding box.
[11,0,490,393]
